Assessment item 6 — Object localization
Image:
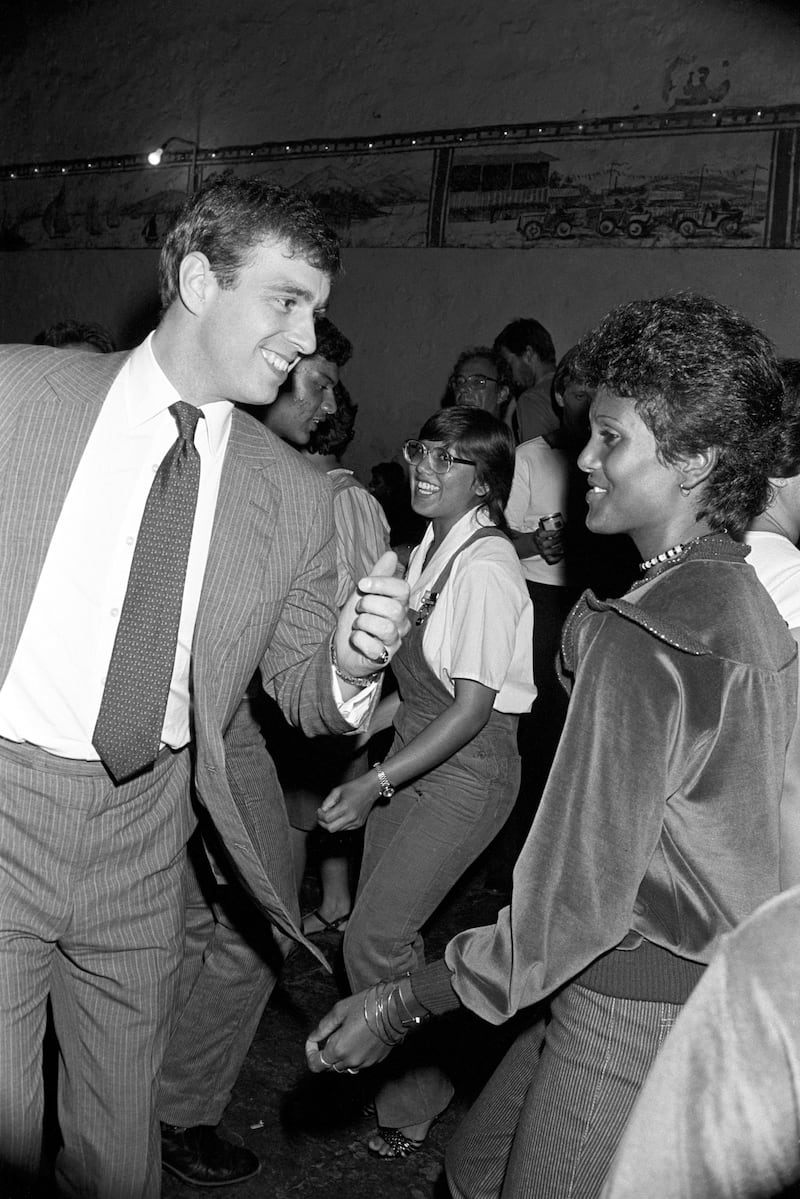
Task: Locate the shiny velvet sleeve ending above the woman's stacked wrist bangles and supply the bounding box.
[445,613,690,1024]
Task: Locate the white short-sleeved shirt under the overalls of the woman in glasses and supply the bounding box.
[407,510,536,712]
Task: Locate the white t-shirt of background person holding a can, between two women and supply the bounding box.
[506,438,570,588]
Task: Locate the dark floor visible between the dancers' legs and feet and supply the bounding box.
[162,869,520,1199]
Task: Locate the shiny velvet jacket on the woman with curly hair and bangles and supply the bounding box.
[411,536,798,1024]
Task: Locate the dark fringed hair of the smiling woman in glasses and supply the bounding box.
[420,404,515,532]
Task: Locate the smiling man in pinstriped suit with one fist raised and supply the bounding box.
[0,180,405,1199]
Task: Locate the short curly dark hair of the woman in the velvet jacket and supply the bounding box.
[575,291,783,534]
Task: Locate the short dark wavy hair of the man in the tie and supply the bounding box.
[158,174,342,309]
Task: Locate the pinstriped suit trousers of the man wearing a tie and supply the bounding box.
[0,740,194,1199]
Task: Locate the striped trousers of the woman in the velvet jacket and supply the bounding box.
[445,983,681,1199]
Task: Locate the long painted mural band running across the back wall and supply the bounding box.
[0,101,800,252]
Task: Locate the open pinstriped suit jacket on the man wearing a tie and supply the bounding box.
[0,347,348,944]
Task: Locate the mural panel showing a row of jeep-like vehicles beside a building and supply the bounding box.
[446,138,769,247]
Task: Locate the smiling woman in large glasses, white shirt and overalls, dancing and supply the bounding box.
[319,406,536,1157]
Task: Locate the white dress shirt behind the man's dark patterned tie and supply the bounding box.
[0,337,233,760]
